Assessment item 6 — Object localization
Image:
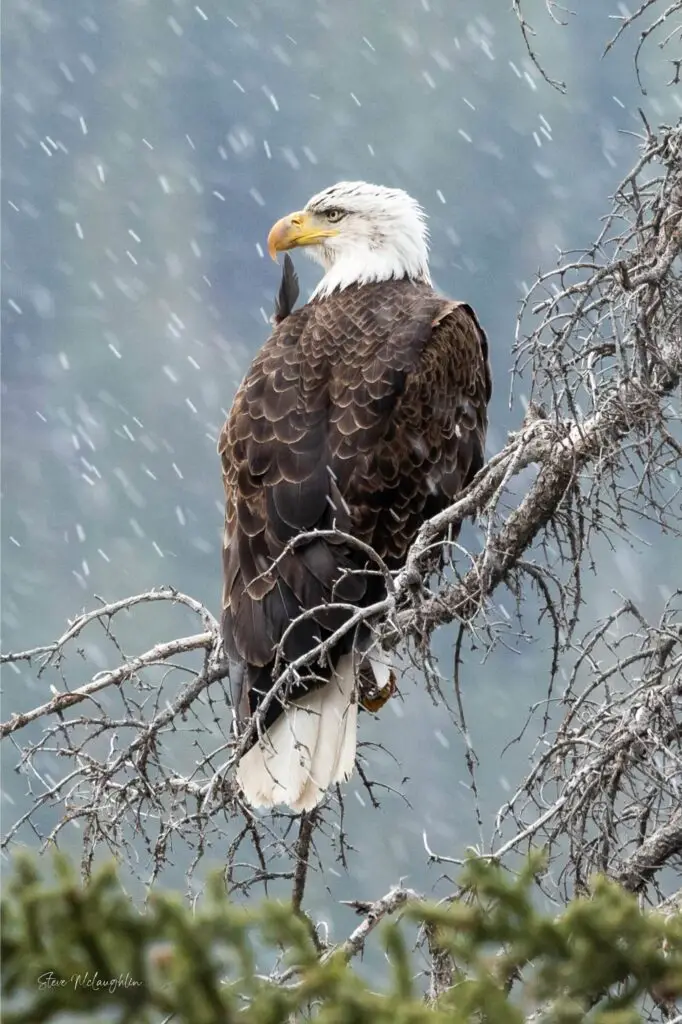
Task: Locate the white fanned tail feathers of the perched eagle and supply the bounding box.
[237,654,357,812]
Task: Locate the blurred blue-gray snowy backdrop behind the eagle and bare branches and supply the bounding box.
[2,0,680,920]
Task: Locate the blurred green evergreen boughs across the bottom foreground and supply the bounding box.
[1,855,682,1024]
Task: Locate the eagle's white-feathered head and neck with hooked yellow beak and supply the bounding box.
[267,181,430,298]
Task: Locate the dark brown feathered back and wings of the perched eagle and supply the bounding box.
[219,280,491,726]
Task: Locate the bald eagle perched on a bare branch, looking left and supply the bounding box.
[219,181,492,811]
